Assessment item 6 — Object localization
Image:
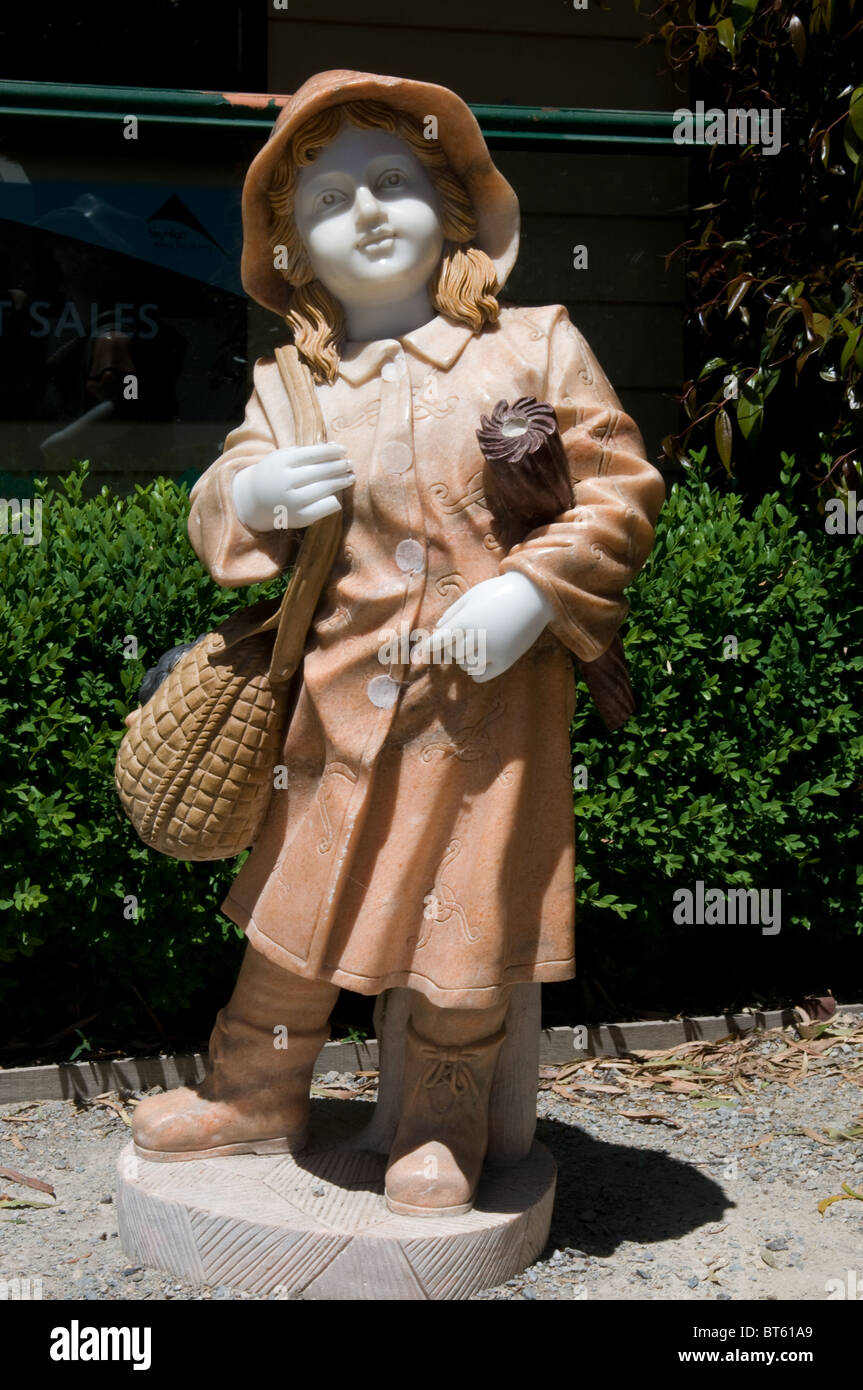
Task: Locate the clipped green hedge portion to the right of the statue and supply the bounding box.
[573,459,863,1008]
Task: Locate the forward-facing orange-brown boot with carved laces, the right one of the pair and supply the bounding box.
[385,1008,506,1216]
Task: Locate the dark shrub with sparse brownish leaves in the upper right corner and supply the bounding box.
[635,0,863,495]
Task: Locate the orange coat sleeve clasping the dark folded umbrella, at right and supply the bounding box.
[500,306,666,662]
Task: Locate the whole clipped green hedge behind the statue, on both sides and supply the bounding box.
[0,466,863,1043]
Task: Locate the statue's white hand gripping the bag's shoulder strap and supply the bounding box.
[232,443,354,531]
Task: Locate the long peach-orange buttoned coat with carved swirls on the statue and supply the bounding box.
[189,304,664,1008]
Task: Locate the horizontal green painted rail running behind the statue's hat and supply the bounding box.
[0,82,685,153]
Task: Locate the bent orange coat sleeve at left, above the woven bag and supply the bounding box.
[189,368,297,587]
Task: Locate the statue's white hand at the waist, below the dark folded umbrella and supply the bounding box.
[411,571,554,684]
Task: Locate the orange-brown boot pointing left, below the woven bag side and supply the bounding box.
[132,947,339,1162]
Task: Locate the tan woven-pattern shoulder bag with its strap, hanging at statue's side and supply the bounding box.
[114,348,342,859]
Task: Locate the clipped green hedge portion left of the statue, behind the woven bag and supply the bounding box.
[0,466,279,1037]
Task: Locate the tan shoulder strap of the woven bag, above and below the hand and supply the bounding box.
[261,345,342,685]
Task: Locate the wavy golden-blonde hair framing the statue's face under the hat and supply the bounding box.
[267,100,499,382]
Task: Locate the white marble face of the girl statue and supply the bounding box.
[293,125,443,322]
